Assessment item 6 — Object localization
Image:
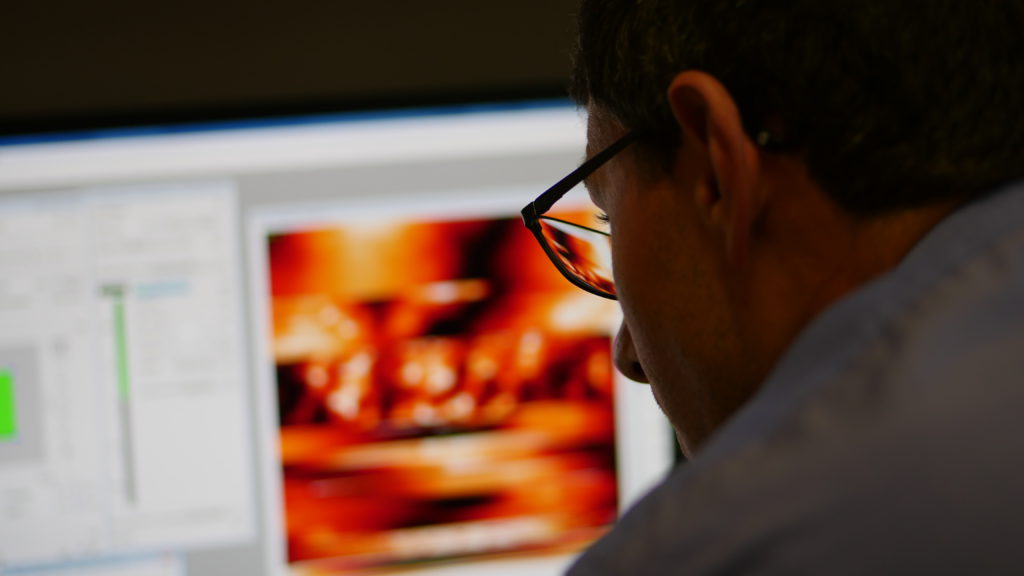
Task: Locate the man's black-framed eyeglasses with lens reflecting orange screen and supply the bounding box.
[522,132,636,300]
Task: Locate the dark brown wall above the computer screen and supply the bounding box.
[0,0,577,132]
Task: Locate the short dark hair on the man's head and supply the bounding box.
[571,0,1024,213]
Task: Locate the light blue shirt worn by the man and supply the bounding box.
[570,184,1024,576]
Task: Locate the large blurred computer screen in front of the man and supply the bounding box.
[0,101,673,576]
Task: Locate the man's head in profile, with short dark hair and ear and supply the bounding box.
[574,0,1024,450]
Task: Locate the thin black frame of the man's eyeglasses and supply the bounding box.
[521,131,637,300]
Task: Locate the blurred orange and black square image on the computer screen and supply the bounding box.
[267,203,617,573]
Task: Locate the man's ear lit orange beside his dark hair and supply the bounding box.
[668,71,764,265]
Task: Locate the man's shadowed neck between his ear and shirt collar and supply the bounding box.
[736,168,956,409]
